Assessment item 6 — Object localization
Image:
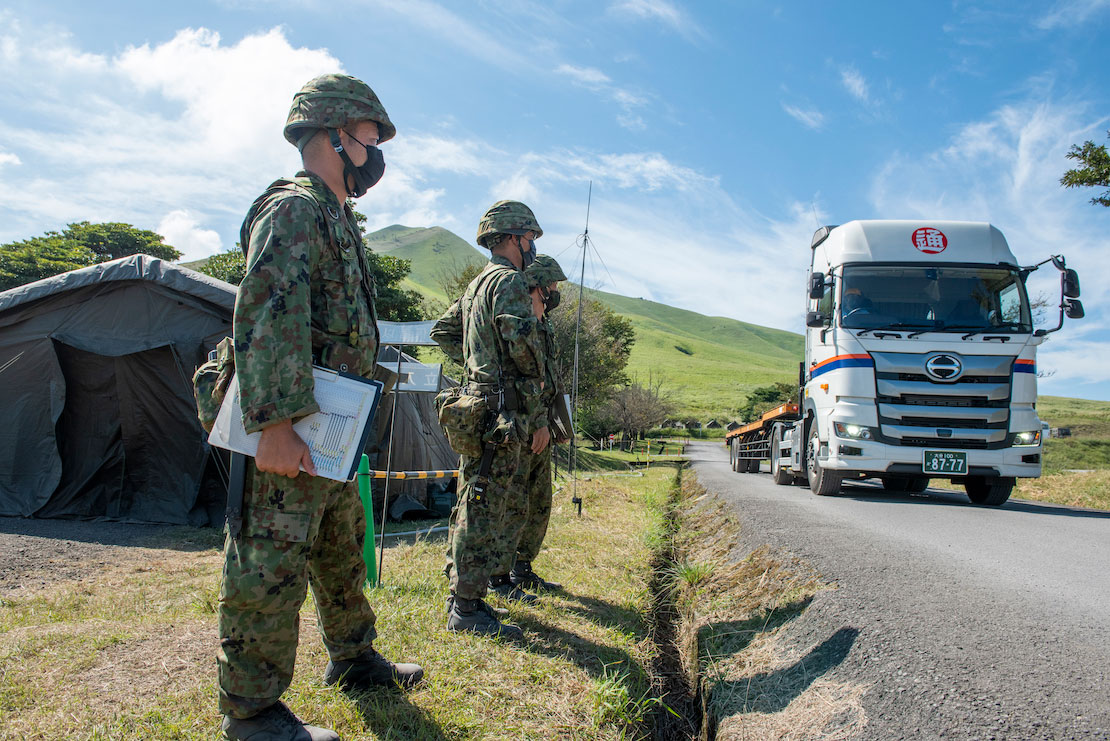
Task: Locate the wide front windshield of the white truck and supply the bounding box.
[838,265,1032,333]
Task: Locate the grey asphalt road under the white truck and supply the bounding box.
[688,443,1110,741]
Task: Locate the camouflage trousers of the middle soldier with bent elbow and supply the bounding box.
[444,444,527,599]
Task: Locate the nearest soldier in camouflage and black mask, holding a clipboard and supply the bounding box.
[218,74,423,741]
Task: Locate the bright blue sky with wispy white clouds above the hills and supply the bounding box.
[0,0,1110,399]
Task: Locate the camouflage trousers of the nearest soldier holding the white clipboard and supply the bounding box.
[216,461,375,718]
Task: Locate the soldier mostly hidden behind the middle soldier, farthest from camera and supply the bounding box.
[491,255,566,591]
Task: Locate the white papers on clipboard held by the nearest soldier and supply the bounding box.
[209,366,382,481]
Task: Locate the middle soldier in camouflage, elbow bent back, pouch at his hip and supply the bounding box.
[432,201,551,638]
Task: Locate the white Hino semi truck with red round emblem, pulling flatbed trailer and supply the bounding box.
[726,221,1083,506]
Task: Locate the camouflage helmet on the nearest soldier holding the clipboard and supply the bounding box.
[285,74,397,145]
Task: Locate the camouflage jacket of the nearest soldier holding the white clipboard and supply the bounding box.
[234,171,377,433]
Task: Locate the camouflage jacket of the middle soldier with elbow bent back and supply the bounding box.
[432,255,547,435]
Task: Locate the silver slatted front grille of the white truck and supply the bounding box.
[871,353,1013,449]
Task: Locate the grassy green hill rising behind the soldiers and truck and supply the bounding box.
[366,225,803,420]
